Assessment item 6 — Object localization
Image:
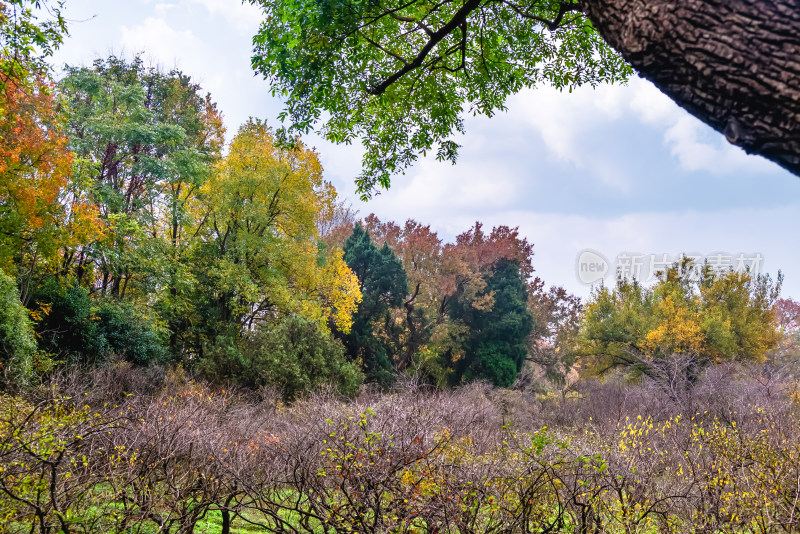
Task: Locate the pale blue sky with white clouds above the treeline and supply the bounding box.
[54,0,800,299]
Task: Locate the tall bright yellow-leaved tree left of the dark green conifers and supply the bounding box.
[197,120,361,340]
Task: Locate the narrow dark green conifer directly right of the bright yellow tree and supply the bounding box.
[339,224,408,386]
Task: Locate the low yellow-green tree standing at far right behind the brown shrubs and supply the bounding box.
[579,260,781,381]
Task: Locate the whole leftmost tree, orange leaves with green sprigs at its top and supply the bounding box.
[0,0,88,304]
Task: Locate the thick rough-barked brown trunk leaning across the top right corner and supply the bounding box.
[584,0,800,175]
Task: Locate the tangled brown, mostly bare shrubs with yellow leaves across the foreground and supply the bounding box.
[0,364,800,533]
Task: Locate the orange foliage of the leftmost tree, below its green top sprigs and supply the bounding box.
[0,70,80,302]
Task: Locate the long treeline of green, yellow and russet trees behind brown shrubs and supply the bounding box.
[0,37,789,399]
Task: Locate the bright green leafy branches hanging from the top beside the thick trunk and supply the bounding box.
[250,0,631,196]
